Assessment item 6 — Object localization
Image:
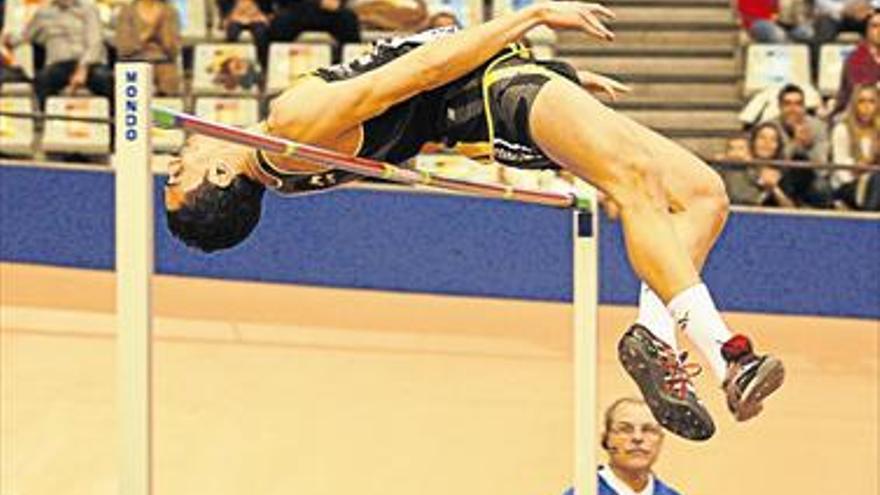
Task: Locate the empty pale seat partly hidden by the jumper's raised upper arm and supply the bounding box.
[266,43,331,94]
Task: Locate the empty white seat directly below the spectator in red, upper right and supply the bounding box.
[744,44,810,96]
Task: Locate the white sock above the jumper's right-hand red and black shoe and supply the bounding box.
[669,283,733,383]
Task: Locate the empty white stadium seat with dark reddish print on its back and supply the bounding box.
[192,43,260,95]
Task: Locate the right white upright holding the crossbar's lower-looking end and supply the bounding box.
[572,202,599,495]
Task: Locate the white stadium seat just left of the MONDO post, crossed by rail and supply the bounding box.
[43,96,110,155]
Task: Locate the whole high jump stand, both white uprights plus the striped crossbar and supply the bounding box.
[113,62,598,495]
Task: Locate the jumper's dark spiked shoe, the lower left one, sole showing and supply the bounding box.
[617,324,715,440]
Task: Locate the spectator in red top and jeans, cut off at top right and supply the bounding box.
[737,0,813,43]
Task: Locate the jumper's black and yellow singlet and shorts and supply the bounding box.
[258,28,577,194]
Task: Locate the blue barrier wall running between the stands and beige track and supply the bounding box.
[0,161,880,318]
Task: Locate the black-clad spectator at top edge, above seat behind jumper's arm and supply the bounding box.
[270,0,361,63]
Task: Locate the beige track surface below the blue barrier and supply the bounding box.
[0,264,880,495]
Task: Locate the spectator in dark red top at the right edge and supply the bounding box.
[831,12,880,118]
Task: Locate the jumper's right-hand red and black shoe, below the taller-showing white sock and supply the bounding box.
[721,335,785,421]
